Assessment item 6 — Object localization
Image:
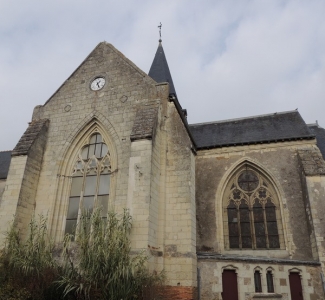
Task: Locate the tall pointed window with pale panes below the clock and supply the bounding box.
[65,133,111,234]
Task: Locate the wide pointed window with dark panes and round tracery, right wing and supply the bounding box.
[224,165,281,249]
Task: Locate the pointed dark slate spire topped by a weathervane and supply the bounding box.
[148,40,176,95]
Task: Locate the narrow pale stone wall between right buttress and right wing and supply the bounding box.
[164,102,196,286]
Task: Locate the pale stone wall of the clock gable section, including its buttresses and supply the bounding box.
[0,43,197,299]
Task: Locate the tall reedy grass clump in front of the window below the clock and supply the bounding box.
[60,210,163,300]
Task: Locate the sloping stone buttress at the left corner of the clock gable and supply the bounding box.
[0,120,48,241]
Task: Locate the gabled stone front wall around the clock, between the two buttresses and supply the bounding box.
[25,43,168,244]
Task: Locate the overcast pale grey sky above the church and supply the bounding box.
[0,0,325,150]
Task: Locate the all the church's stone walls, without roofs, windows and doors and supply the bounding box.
[0,42,325,300]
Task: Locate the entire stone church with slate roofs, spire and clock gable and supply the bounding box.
[0,40,325,300]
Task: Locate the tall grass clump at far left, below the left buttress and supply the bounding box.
[0,216,58,299]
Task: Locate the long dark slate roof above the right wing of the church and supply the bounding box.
[190,111,315,149]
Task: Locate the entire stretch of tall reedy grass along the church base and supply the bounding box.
[0,209,163,300]
